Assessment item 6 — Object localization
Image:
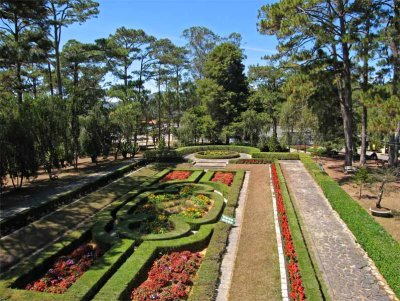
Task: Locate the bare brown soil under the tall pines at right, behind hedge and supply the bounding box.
[314,157,400,241]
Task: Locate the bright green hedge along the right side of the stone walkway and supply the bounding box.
[300,154,400,297]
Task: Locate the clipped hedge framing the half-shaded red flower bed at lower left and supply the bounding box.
[0,168,170,301]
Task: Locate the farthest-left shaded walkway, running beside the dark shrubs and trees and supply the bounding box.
[0,160,139,220]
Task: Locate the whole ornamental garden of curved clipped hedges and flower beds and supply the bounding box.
[0,166,244,301]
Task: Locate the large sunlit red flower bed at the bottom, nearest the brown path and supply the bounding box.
[131,251,202,301]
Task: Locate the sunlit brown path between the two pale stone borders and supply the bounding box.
[227,164,281,301]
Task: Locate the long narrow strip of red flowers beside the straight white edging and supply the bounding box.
[271,164,306,301]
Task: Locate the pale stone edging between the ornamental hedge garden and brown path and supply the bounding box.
[215,171,250,301]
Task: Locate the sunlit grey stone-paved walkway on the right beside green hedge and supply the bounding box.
[281,161,395,301]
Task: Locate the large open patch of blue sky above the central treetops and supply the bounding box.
[62,0,277,88]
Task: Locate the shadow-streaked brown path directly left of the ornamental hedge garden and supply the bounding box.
[0,167,157,272]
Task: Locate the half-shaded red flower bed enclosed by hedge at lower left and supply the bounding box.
[25,244,101,294]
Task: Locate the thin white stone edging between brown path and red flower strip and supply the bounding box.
[269,165,289,301]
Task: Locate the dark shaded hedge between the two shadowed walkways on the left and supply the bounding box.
[0,160,146,236]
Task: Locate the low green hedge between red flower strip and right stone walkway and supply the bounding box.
[275,161,328,301]
